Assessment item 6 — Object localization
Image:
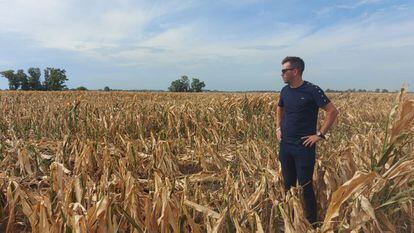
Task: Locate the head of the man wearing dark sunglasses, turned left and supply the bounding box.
[282,57,305,84]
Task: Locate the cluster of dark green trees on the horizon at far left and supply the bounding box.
[0,67,68,91]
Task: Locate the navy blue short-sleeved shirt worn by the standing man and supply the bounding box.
[278,81,330,142]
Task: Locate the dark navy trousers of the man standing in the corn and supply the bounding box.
[279,141,316,224]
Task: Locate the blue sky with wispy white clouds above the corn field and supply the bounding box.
[0,0,414,90]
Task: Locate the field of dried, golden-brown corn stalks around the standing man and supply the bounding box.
[0,91,414,233]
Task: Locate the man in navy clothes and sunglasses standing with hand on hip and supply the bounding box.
[276,57,338,224]
